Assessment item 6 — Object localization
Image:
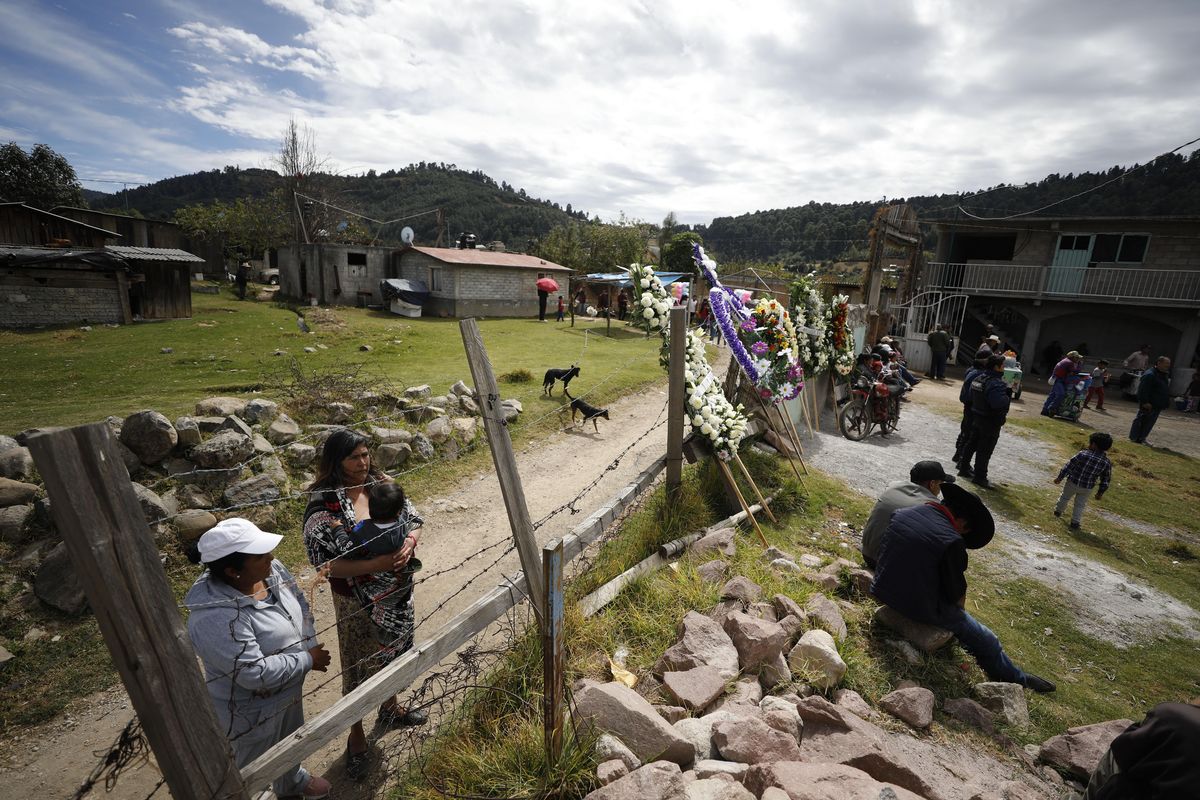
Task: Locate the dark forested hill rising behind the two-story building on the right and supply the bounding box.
[695,151,1200,264]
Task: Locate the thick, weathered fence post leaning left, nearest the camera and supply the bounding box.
[29,422,248,800]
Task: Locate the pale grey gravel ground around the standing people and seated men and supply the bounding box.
[802,381,1200,646]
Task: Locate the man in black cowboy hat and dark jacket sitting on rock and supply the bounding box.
[871,483,1055,692]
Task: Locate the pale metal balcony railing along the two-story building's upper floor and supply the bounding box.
[923,261,1200,306]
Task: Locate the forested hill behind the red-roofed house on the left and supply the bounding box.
[86,162,587,248]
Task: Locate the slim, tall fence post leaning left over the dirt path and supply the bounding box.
[458,318,545,626]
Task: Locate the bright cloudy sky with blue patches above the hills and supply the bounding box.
[0,0,1200,223]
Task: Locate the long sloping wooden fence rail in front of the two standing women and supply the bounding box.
[241,570,527,786]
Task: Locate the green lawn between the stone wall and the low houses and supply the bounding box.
[0,290,665,433]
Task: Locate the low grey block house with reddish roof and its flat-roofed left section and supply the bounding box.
[278,243,571,317]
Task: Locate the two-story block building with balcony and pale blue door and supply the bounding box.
[908,217,1200,390]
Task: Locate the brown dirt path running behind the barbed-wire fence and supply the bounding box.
[0,381,686,800]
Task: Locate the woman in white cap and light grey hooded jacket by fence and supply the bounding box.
[184,517,330,800]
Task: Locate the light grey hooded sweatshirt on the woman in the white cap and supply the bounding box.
[184,560,317,739]
